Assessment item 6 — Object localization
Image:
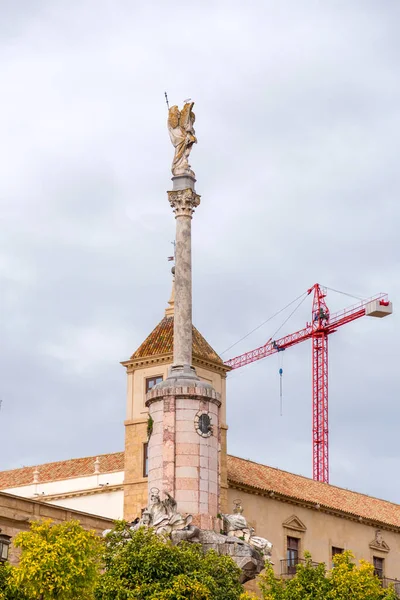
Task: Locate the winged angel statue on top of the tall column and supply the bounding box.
[168,102,197,177]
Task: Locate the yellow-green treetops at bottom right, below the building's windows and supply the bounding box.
[259,552,397,600]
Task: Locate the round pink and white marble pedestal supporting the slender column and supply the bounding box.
[146,366,221,529]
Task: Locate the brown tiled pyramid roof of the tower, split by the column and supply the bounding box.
[131,317,224,365]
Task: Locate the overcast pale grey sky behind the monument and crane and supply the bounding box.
[0,0,400,503]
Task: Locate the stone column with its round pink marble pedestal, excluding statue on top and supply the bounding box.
[146,175,221,529]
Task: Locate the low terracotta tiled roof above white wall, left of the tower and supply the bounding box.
[0,452,124,490]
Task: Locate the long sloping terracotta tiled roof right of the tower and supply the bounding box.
[228,456,400,527]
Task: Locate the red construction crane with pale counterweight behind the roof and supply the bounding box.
[225,283,392,483]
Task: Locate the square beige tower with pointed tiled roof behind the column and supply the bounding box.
[122,285,230,521]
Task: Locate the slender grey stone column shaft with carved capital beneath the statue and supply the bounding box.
[168,177,200,372]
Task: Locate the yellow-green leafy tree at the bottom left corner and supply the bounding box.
[12,521,103,600]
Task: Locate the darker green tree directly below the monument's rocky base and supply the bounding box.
[96,522,243,600]
